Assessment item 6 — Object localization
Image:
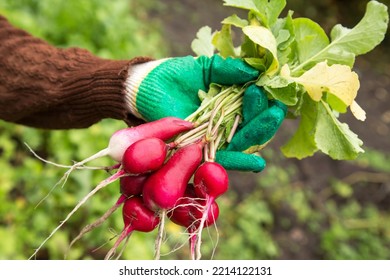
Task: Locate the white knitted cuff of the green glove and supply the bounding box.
[124,59,167,119]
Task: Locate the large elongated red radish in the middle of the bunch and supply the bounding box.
[142,141,204,211]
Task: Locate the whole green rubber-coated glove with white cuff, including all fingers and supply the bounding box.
[126,55,285,172]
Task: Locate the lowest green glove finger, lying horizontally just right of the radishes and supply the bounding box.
[215,150,265,172]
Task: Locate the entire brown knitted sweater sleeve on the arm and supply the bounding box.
[0,15,150,129]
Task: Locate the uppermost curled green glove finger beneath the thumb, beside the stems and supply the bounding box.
[240,84,268,127]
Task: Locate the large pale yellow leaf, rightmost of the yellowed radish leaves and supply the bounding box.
[290,62,360,106]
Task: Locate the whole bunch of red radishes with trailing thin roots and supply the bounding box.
[30,117,232,259]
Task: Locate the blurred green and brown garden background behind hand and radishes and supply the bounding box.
[0,0,390,260]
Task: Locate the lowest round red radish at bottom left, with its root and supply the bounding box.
[105,196,160,259]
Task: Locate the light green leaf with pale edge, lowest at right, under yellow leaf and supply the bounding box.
[315,101,364,160]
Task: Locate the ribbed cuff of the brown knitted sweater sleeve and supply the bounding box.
[54,57,151,127]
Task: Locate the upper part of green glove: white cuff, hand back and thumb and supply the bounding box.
[126,55,259,121]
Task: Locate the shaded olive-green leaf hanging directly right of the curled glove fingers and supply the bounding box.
[281,94,318,159]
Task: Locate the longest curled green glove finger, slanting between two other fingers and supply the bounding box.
[226,101,287,151]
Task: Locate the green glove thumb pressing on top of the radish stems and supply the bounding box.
[196,55,260,87]
